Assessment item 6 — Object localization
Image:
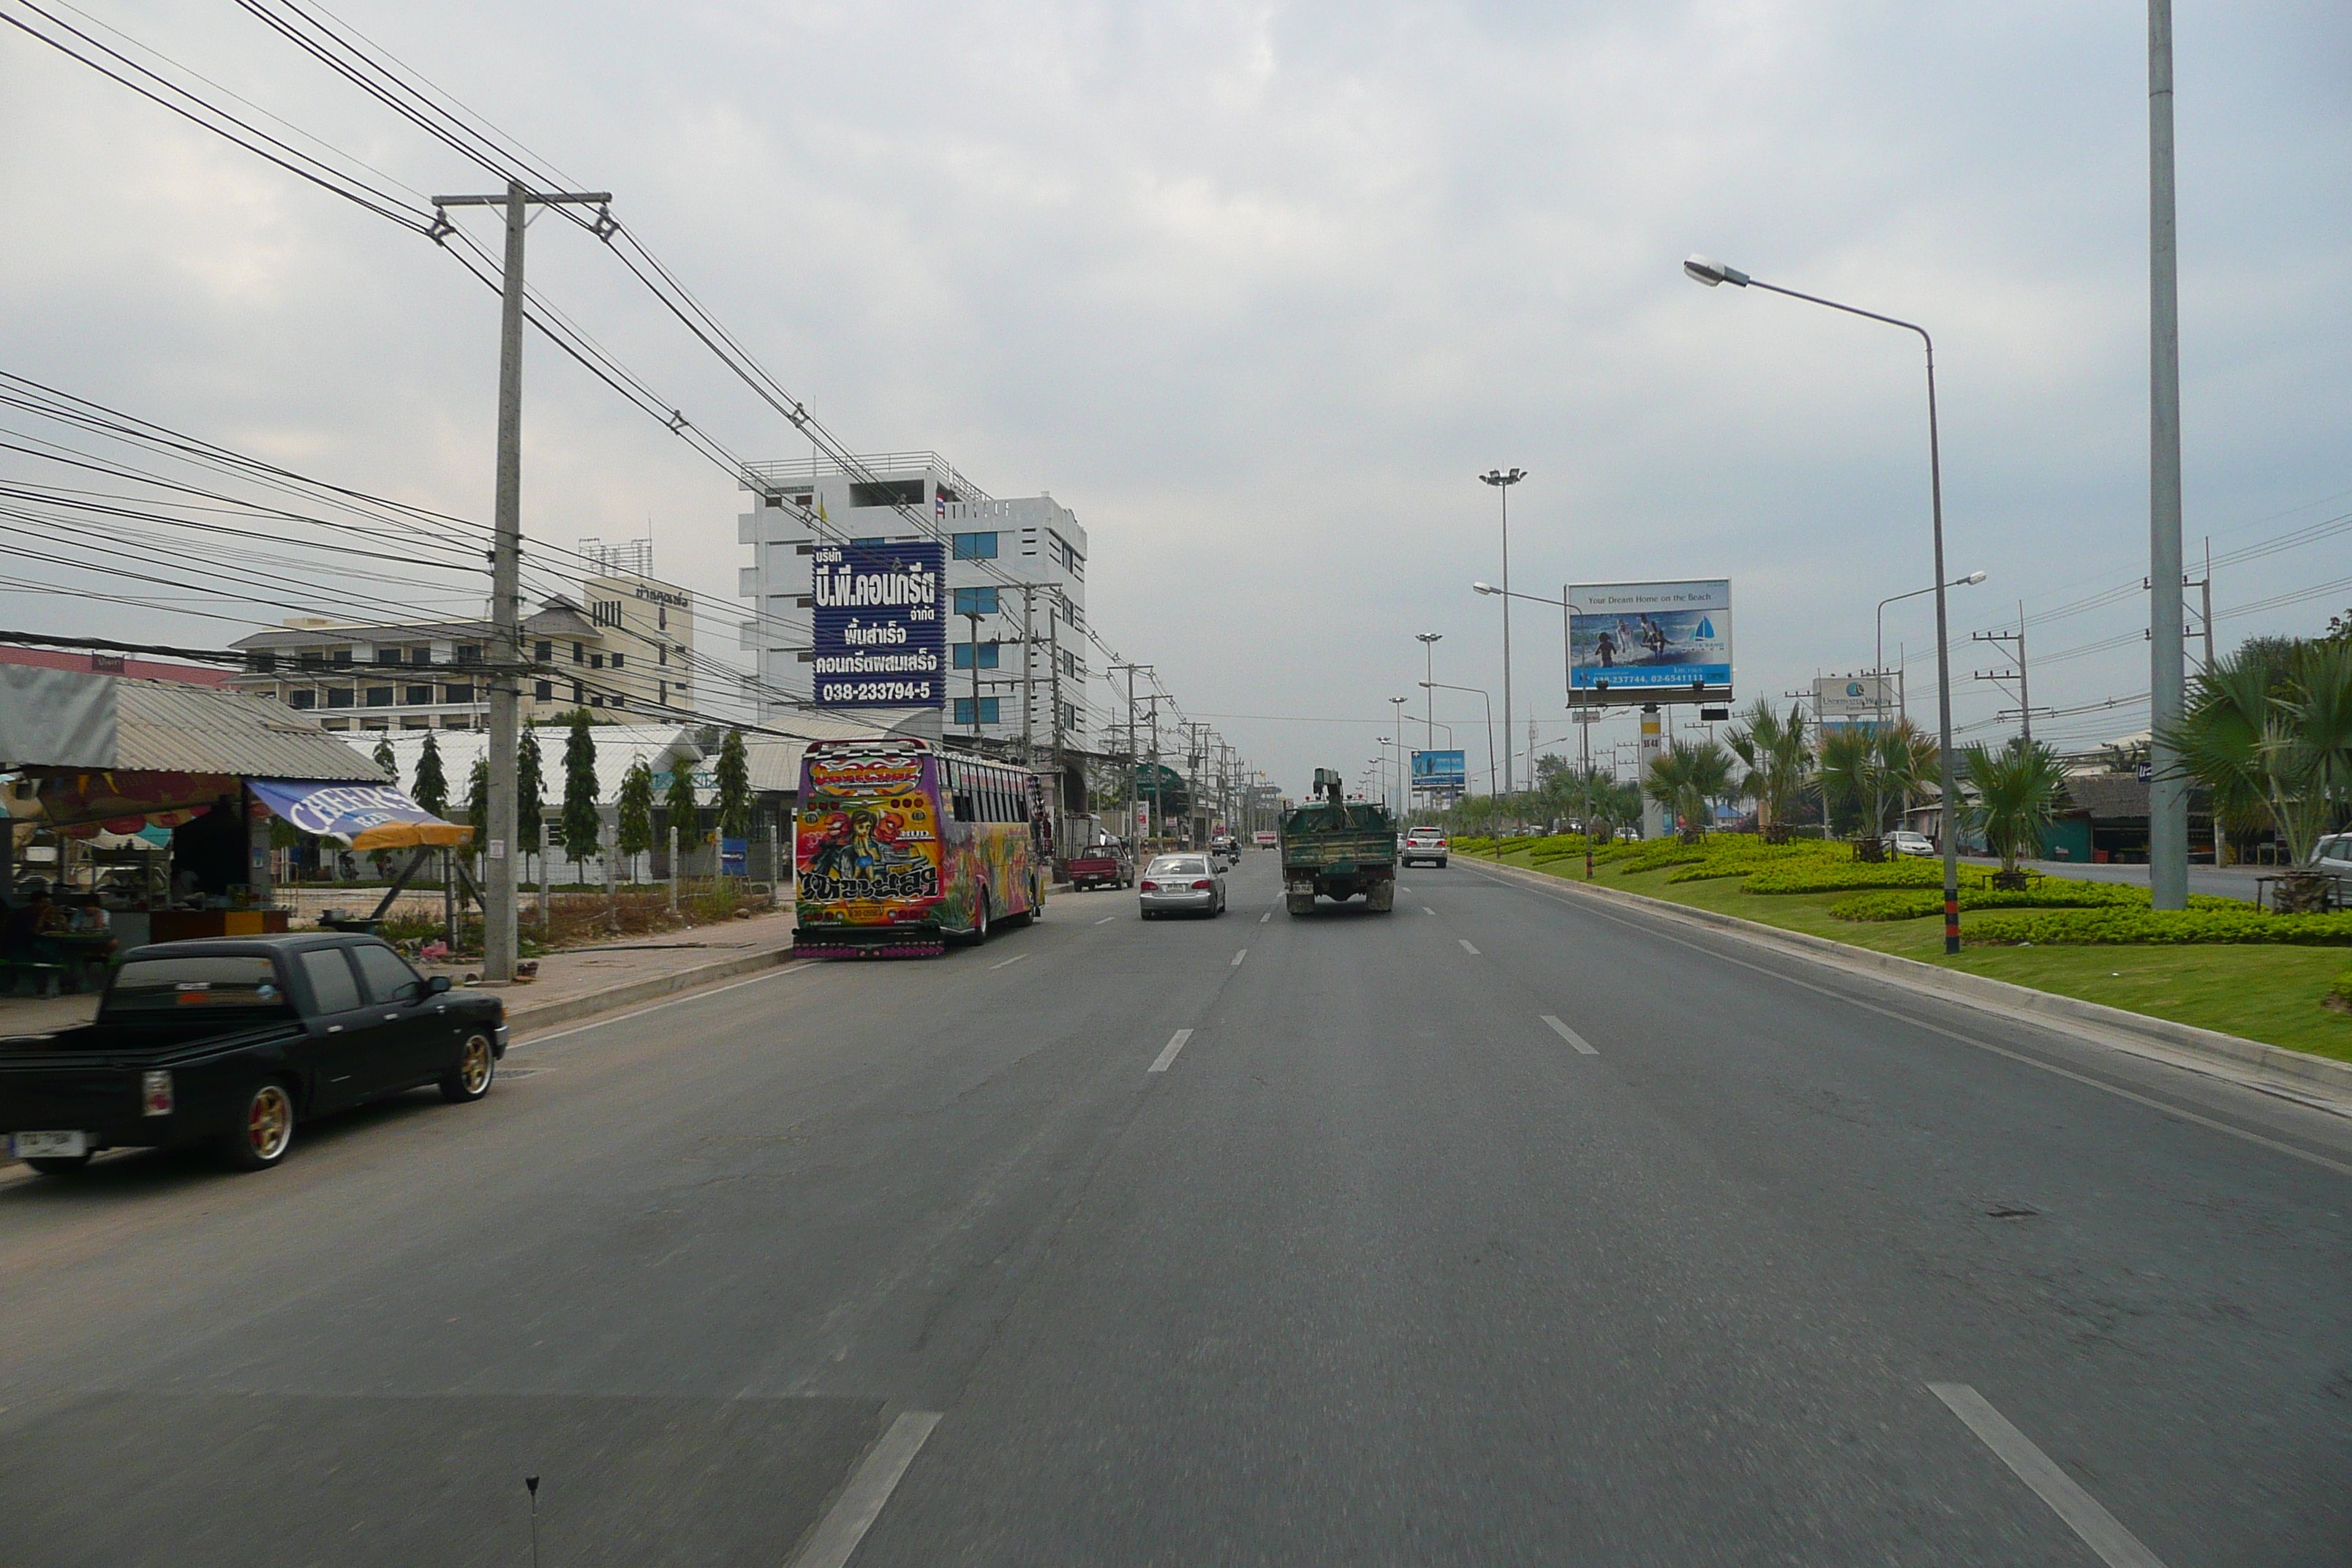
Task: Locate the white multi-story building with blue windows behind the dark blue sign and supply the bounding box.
[736,451,1087,747]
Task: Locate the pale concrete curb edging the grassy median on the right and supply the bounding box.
[1466,858,2352,1115]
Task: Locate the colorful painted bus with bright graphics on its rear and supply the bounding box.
[793,738,1052,959]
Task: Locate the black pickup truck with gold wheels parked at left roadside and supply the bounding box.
[0,933,505,1175]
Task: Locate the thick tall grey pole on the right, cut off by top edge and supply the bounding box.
[2147,0,2190,910]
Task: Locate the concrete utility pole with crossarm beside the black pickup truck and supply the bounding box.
[433,181,611,985]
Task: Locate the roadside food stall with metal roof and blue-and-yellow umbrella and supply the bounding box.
[0,668,470,985]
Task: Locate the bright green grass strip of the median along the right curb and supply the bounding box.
[1480,832,2352,1063]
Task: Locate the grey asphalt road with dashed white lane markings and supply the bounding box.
[0,853,2352,1568]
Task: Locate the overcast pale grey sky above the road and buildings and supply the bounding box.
[0,0,2352,790]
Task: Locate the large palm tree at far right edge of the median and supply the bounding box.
[2164,642,2352,910]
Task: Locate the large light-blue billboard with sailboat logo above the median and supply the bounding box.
[1567,578,1731,705]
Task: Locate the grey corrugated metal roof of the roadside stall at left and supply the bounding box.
[116,677,383,783]
